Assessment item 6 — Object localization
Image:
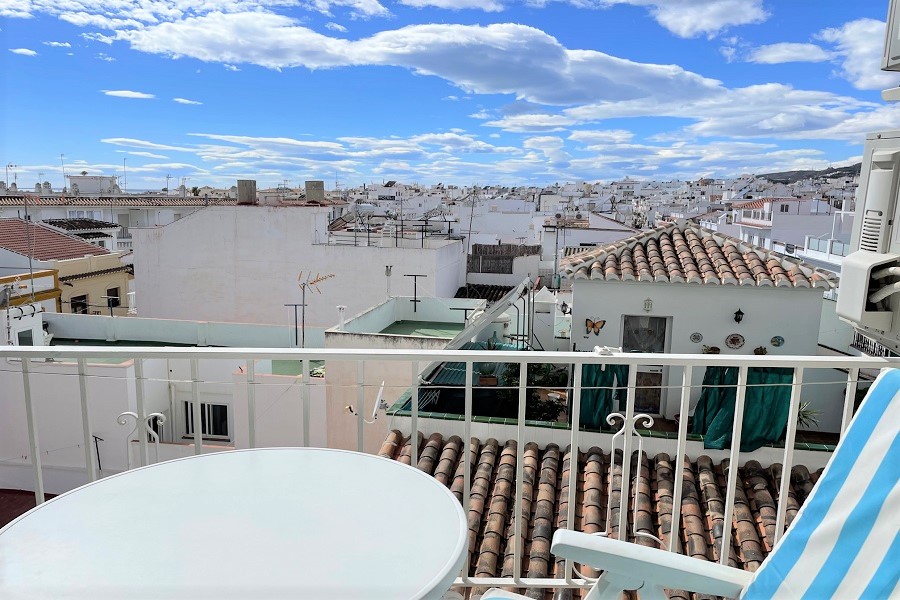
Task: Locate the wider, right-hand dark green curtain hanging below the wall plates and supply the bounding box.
[691,367,794,452]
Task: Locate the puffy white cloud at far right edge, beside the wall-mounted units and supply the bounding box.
[817,19,900,90]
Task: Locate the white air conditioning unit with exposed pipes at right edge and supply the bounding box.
[837,131,900,340]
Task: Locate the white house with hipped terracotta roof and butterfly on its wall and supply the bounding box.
[561,223,846,431]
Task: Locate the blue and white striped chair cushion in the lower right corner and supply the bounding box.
[741,369,900,600]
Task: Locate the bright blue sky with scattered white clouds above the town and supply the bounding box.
[0,0,900,190]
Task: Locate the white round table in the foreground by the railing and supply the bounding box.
[0,448,467,600]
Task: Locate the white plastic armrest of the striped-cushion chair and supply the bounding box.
[551,529,753,598]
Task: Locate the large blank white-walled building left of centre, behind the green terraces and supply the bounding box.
[132,205,466,327]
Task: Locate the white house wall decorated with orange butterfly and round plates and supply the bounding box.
[572,279,846,431]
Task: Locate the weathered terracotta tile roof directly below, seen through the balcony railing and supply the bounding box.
[379,430,821,598]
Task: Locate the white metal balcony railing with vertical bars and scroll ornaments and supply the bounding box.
[0,346,900,593]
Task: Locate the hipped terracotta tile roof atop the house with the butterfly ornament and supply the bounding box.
[560,223,836,289]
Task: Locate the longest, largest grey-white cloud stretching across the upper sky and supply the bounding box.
[117,13,720,104]
